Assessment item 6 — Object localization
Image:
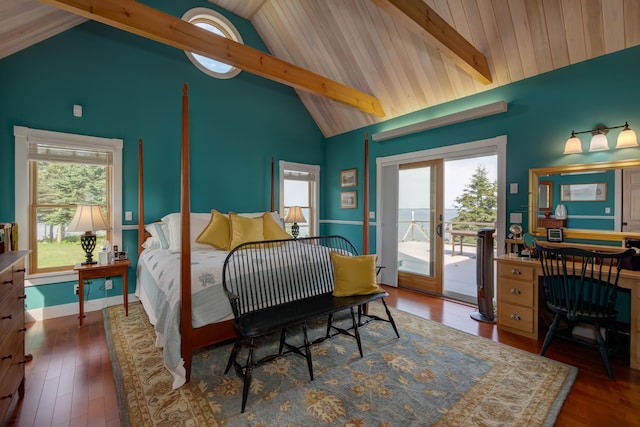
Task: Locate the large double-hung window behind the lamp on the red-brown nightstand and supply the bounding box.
[14,126,122,275]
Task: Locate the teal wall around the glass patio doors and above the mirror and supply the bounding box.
[322,47,640,252]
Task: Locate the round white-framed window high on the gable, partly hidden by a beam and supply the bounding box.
[182,7,243,79]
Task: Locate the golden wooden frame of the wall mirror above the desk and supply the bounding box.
[528,159,640,243]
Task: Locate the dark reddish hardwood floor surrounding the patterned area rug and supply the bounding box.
[9,288,640,427]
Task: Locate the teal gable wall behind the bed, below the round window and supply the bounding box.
[0,0,324,308]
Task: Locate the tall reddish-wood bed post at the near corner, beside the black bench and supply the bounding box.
[180,83,193,382]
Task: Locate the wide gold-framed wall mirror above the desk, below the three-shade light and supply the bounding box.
[529,159,640,241]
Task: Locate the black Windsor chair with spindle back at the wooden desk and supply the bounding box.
[536,242,635,380]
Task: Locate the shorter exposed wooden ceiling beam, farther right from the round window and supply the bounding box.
[371,0,493,84]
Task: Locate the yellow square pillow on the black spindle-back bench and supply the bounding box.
[330,251,383,297]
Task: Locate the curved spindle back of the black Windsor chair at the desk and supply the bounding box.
[536,242,635,322]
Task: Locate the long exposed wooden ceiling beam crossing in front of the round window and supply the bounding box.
[40,0,385,117]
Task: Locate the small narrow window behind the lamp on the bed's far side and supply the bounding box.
[280,161,320,237]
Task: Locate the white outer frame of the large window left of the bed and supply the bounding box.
[13,126,123,284]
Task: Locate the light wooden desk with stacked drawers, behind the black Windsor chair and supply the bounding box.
[496,255,640,369]
